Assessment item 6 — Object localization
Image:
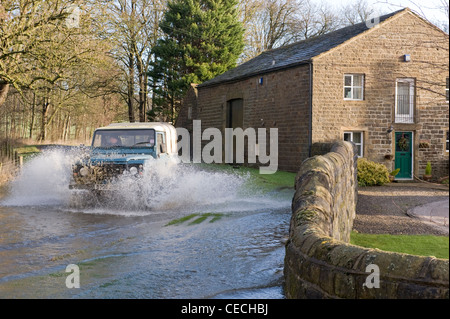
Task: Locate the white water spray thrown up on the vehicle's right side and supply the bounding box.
[97,159,247,211]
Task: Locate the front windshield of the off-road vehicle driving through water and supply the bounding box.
[92,129,155,148]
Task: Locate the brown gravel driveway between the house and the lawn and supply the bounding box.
[353,183,449,236]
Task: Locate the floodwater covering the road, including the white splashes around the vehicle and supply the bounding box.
[0,150,293,299]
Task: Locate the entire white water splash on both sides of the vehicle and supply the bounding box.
[0,149,253,211]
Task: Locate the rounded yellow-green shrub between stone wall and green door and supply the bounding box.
[358,158,389,186]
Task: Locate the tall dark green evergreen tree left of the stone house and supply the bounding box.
[148,0,244,121]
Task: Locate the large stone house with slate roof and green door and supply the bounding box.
[176,9,449,180]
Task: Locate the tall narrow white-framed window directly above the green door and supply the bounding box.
[395,79,415,123]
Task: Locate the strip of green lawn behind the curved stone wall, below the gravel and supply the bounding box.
[350,232,449,259]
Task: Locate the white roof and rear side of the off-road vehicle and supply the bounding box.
[96,122,178,154]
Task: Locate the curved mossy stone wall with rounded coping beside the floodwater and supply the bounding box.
[284,142,449,299]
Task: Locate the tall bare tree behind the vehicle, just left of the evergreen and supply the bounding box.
[104,0,165,122]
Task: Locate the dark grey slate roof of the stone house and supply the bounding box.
[199,9,407,87]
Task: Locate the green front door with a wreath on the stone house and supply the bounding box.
[395,132,414,179]
